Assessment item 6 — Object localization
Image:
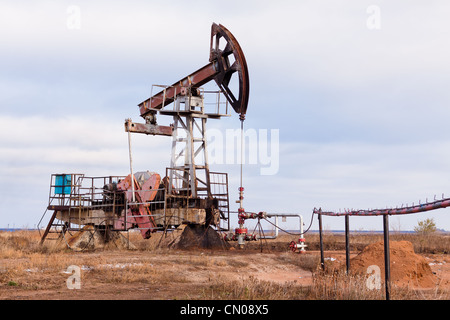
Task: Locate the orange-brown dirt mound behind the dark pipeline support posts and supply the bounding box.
[350,241,437,288]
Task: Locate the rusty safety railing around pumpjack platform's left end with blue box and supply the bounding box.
[38,174,166,232]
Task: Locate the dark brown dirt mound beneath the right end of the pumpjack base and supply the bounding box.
[173,224,230,249]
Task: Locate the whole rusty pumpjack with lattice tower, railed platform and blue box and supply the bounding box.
[39,23,249,248]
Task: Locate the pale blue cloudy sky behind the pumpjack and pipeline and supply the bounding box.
[0,0,450,231]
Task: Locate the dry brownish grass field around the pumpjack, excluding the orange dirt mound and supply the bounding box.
[0,231,450,300]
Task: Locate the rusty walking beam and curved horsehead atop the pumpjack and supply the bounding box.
[138,23,250,119]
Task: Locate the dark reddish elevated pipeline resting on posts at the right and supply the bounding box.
[313,198,450,216]
